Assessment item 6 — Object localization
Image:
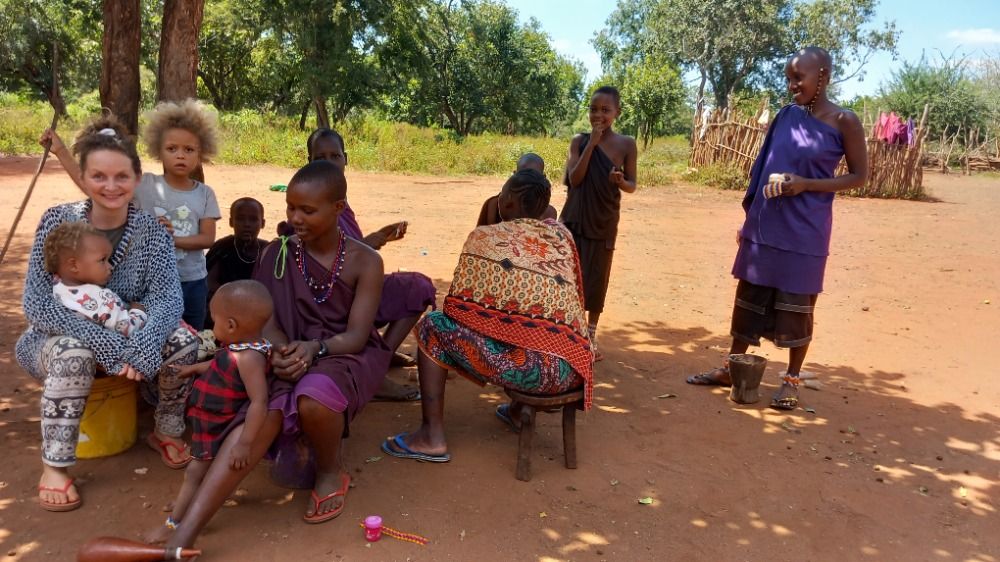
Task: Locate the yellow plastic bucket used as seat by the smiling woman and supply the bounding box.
[76,377,139,459]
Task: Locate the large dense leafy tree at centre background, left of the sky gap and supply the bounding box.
[389,0,583,136]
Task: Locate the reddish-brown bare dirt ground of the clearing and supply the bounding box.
[0,154,1000,562]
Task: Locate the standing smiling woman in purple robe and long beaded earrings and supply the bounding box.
[687,47,868,410]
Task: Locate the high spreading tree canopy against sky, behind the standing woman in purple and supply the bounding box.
[594,0,898,107]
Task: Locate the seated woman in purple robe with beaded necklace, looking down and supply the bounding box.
[254,160,392,523]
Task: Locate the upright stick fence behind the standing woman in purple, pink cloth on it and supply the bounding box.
[690,104,928,199]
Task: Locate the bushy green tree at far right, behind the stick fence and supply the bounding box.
[880,57,989,138]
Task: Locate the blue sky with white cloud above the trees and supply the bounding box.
[507,0,1000,99]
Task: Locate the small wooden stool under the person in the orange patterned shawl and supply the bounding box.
[504,388,583,482]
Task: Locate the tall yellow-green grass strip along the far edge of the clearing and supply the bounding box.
[0,99,688,187]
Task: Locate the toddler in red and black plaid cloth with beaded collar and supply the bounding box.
[147,279,274,542]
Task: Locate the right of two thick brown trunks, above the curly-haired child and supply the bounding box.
[156,0,205,101]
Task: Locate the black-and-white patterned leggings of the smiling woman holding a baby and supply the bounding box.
[19,328,199,467]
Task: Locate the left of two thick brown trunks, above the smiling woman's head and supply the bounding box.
[100,0,142,135]
